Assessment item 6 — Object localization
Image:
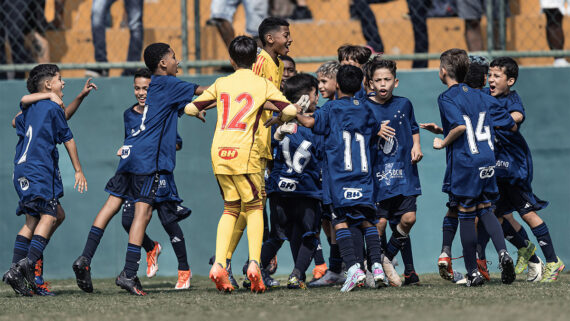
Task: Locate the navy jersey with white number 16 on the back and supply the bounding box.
[265,126,324,200]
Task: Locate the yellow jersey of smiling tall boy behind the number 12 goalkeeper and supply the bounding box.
[252,49,284,159]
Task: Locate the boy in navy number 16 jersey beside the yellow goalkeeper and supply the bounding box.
[261,74,323,289]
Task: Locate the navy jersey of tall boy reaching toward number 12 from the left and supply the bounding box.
[117,76,198,175]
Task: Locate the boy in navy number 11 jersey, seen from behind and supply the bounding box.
[297,65,384,292]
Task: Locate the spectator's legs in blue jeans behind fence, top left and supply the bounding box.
[85,0,144,77]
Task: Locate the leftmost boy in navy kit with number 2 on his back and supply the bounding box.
[3,64,87,296]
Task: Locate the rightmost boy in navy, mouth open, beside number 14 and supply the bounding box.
[488,57,564,282]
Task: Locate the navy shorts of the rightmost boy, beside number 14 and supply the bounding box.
[495,182,548,217]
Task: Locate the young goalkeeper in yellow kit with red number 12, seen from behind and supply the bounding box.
[185,36,297,292]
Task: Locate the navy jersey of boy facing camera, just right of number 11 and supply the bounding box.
[366,96,422,202]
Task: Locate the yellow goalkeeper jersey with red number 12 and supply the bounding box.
[185,69,297,175]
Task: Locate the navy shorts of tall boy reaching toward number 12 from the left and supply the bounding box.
[105,173,160,205]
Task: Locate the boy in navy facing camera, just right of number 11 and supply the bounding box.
[366,60,423,286]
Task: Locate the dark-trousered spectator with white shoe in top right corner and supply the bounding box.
[540,0,570,67]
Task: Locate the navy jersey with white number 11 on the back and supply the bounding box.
[313,97,380,208]
